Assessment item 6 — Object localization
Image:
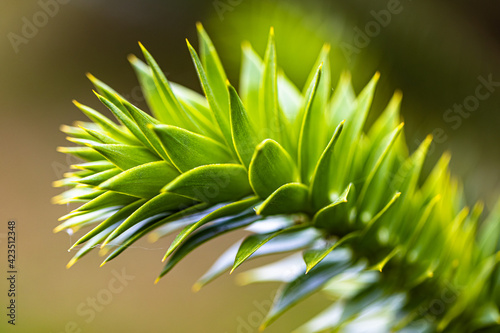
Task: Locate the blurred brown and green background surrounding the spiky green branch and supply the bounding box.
[0,0,500,333]
